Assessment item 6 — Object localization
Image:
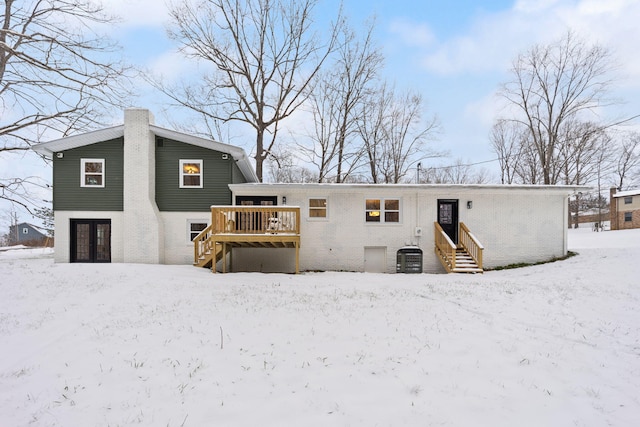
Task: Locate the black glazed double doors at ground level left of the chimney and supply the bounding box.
[71,219,111,262]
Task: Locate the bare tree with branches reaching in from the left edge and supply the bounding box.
[0,0,130,212]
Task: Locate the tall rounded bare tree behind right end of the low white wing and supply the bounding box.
[501,32,613,184]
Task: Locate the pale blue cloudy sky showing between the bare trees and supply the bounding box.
[0,0,640,225]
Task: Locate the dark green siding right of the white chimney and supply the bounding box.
[156,138,244,212]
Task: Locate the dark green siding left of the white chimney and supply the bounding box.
[53,138,124,211]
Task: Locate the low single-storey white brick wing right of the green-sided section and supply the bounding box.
[229,184,582,272]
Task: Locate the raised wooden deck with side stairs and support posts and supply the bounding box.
[193,206,300,274]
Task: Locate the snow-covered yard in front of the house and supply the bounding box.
[0,228,640,427]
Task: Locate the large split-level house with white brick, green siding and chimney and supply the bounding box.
[34,109,584,273]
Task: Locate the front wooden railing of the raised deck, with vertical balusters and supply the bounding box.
[211,206,300,234]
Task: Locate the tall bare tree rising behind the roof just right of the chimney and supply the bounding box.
[162,0,341,181]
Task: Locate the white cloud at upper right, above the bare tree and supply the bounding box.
[422,0,640,80]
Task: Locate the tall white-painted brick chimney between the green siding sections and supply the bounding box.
[122,108,164,264]
